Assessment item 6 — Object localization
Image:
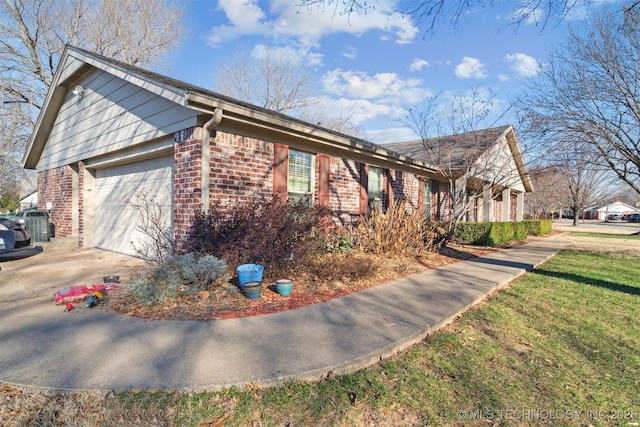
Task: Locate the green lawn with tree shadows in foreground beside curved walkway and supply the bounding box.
[109,251,640,426]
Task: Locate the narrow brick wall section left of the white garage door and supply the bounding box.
[38,166,74,237]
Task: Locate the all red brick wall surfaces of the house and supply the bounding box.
[32,122,428,251]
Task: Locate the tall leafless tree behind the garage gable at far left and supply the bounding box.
[0,0,185,201]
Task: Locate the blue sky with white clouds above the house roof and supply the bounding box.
[163,0,604,143]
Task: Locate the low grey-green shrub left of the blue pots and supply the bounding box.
[127,253,229,305]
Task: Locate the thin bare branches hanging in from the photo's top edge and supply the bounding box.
[298,0,591,33]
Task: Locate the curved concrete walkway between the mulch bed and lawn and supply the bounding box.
[0,239,569,390]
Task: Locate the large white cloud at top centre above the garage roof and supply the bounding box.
[208,0,419,46]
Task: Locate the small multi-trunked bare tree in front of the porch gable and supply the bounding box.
[398,88,520,238]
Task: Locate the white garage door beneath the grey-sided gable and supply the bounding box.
[95,156,173,255]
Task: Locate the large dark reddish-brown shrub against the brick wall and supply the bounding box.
[187,196,328,277]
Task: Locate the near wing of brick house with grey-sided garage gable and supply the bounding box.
[23,47,527,255]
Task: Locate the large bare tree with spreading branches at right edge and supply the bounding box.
[521,6,640,193]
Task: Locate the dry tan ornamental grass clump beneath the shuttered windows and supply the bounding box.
[351,201,444,255]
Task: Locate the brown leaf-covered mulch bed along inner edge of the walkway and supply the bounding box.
[107,246,497,320]
